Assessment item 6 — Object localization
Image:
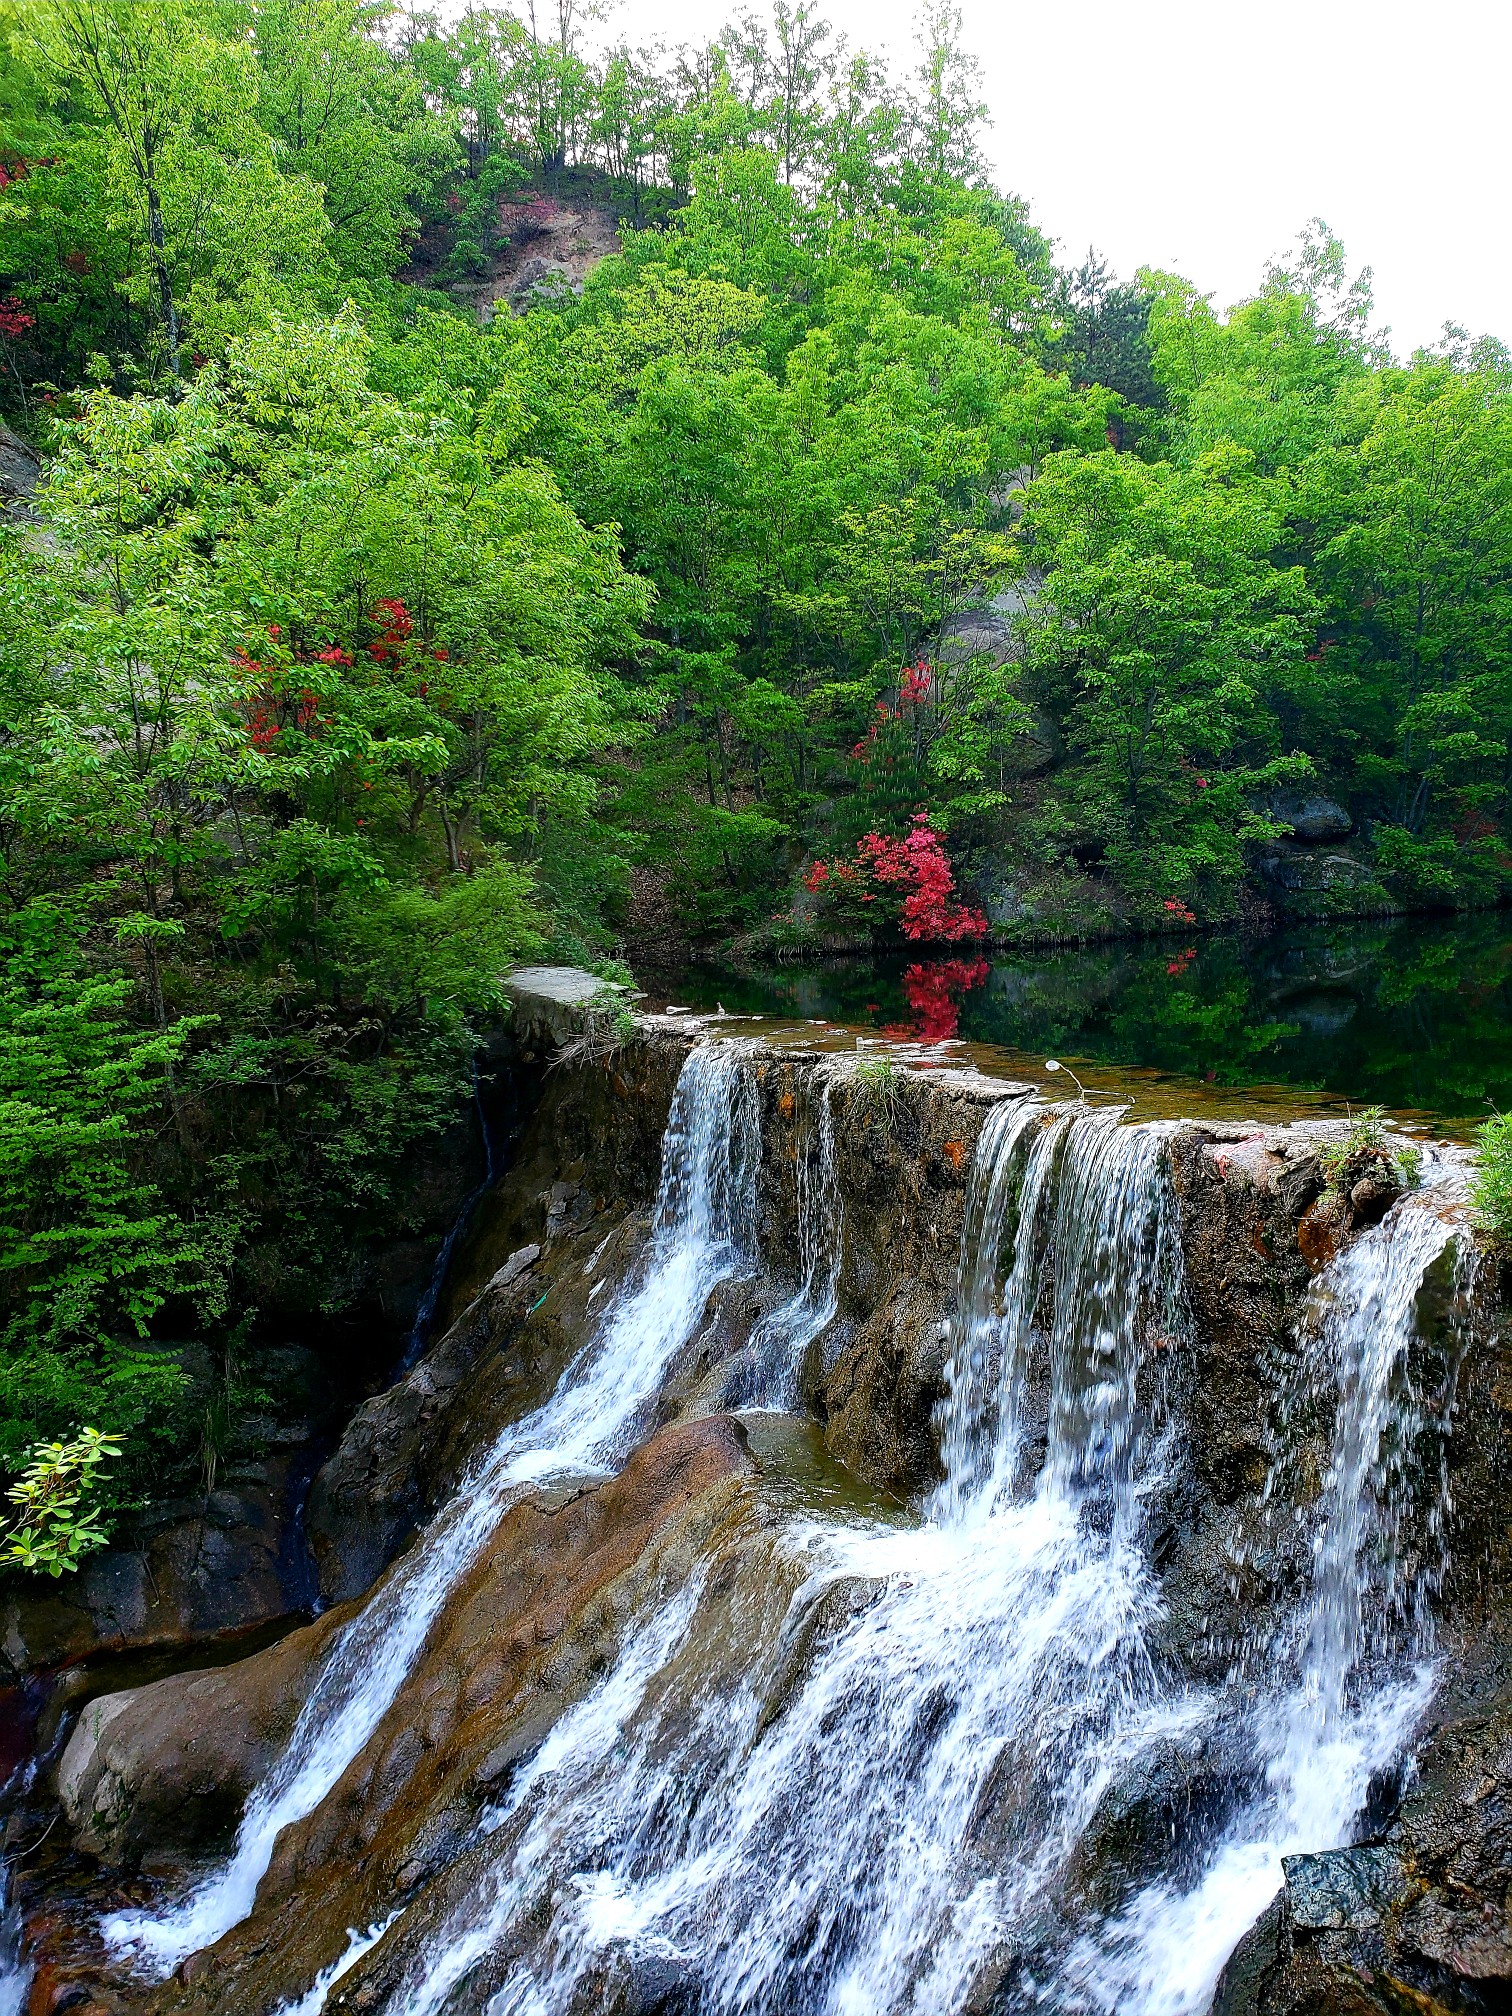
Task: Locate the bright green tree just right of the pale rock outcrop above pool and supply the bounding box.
[1028,448,1310,919]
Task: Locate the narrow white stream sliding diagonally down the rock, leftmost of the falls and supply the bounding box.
[101,1042,760,1974]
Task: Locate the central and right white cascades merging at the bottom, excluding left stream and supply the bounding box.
[370,1103,1454,2016]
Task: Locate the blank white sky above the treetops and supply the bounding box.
[599,0,1512,355]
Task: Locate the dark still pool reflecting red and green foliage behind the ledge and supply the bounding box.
[661,911,1512,1123]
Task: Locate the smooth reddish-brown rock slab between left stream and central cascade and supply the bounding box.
[142,1415,754,2016]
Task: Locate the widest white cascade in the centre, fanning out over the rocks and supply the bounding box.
[372,1109,1202,2016]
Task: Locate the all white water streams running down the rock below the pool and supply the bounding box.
[68,1040,1483,2016]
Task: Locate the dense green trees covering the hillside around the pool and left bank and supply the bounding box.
[0,0,1512,1516]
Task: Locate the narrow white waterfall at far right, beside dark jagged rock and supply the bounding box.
[1054,1198,1460,2016]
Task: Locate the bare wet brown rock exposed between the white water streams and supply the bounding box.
[11,991,1512,2016]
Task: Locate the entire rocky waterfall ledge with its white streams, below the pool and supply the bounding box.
[0,972,1512,2016]
